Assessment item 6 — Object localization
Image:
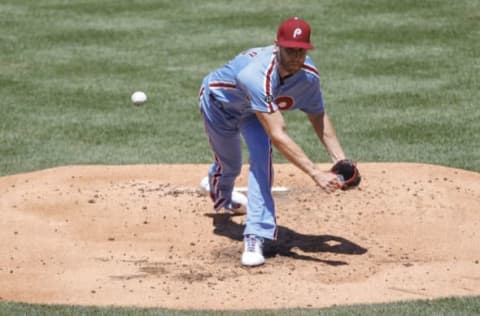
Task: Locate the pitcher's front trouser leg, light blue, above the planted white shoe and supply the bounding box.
[240,118,276,239]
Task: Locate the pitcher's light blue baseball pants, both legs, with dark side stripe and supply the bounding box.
[200,94,276,239]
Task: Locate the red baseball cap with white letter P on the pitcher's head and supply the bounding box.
[277,17,313,49]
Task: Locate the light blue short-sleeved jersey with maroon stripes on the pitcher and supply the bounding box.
[203,46,324,124]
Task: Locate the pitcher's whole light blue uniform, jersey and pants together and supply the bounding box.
[199,46,324,239]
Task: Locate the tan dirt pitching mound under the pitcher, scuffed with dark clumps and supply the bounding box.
[0,163,480,309]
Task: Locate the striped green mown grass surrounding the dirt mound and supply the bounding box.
[0,0,480,315]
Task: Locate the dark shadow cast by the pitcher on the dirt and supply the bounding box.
[212,214,367,266]
